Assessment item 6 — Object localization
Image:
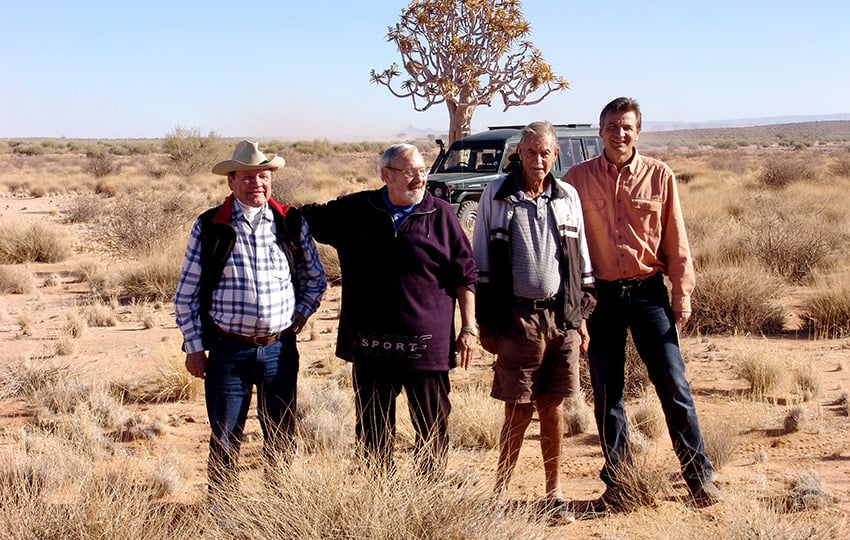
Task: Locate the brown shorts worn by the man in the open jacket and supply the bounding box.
[490,306,581,403]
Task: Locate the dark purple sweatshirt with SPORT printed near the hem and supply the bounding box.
[301,188,478,371]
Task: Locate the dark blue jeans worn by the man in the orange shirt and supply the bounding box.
[587,273,713,489]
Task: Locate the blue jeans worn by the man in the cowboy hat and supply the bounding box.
[204,332,298,487]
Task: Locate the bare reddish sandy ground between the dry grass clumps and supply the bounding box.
[0,197,850,538]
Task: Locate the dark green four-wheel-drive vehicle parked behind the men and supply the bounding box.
[428,124,603,234]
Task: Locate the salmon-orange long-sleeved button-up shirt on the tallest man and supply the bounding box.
[563,150,695,312]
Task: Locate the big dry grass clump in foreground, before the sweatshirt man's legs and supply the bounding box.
[229,452,551,540]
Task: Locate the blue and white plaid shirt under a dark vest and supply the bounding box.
[174,200,327,353]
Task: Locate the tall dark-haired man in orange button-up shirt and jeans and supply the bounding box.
[563,97,722,509]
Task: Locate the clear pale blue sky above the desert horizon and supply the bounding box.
[0,0,850,140]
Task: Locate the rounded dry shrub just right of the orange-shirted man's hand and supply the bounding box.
[687,266,784,334]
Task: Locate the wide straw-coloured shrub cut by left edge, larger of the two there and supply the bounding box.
[0,223,71,264]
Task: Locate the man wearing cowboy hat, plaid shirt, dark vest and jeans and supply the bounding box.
[174,141,327,491]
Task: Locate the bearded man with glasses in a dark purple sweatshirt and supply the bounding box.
[302,144,478,476]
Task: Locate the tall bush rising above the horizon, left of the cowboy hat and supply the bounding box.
[162,126,227,178]
